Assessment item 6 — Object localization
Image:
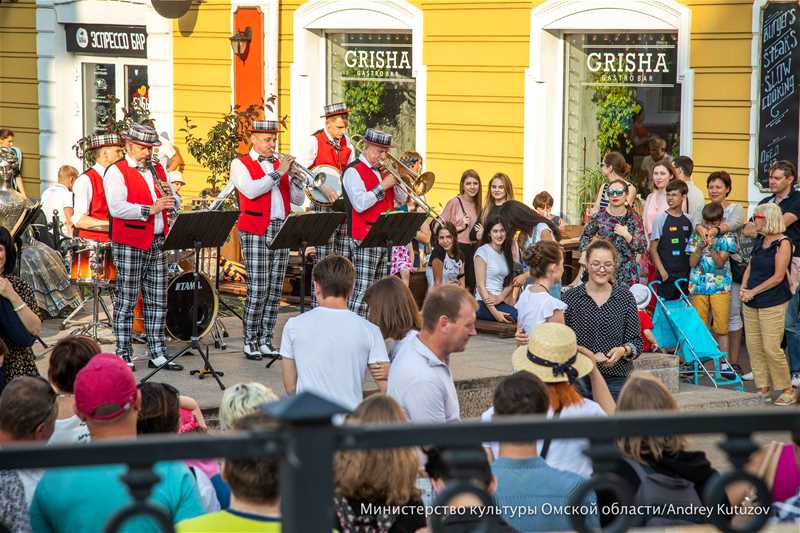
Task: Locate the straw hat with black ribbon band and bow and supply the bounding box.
[511,322,594,383]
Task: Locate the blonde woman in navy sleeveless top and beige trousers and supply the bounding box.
[739,204,797,406]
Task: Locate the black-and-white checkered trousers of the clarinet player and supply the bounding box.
[111,239,167,358]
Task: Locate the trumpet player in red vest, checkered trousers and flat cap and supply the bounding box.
[230,120,304,361]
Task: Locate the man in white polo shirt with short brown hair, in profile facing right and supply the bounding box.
[388,285,478,423]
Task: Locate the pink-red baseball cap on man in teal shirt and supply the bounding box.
[74,353,138,420]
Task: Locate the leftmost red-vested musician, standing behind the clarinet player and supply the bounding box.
[72,133,125,242]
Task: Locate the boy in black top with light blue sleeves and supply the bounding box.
[650,180,693,300]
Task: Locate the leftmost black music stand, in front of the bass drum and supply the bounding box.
[140,211,239,390]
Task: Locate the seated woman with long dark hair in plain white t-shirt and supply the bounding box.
[475,215,517,323]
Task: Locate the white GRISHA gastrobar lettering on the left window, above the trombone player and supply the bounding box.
[342,34,412,81]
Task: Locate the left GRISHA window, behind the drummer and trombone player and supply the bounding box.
[326,32,416,152]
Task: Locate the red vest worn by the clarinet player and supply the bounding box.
[111,159,169,250]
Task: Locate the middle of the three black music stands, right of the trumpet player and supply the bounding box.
[267,211,347,314]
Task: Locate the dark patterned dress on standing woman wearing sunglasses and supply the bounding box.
[580,209,647,287]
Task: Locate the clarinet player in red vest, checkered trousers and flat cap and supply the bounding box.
[103,124,177,370]
